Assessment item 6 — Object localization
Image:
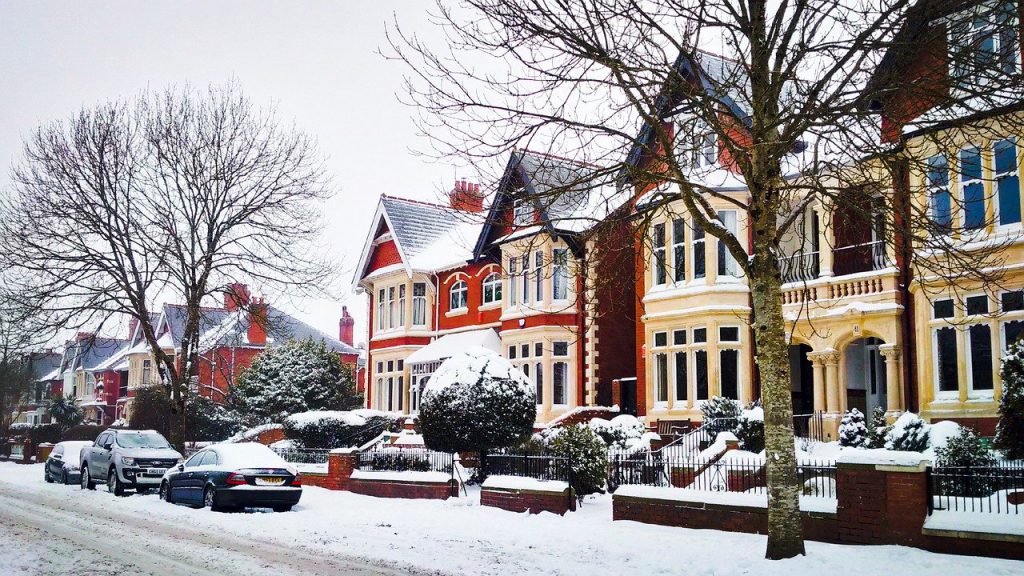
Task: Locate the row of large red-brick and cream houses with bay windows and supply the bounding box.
[353,2,1024,439]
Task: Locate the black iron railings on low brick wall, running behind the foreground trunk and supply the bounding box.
[608,452,836,499]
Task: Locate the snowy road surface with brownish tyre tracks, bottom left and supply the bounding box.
[0,466,440,576]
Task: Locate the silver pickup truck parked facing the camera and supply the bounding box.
[81,428,184,496]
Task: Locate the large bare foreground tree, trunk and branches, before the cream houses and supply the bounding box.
[388,0,1021,559]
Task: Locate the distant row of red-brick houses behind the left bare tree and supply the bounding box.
[17,284,362,424]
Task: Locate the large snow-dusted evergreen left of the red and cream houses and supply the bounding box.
[230,339,362,424]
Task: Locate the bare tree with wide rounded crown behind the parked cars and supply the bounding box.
[0,85,332,445]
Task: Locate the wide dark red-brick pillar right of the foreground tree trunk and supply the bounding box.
[836,461,928,546]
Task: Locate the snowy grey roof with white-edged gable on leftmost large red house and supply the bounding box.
[352,195,482,286]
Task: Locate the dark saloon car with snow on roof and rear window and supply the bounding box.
[160,443,302,512]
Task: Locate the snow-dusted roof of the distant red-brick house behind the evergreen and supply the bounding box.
[199,304,359,355]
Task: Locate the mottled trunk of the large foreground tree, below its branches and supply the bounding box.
[750,245,805,560]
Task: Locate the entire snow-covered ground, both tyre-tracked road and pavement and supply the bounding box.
[0,463,1022,576]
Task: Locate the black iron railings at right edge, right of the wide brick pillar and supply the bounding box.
[928,462,1024,515]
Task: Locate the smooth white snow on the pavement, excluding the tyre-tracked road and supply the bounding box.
[0,463,1022,576]
